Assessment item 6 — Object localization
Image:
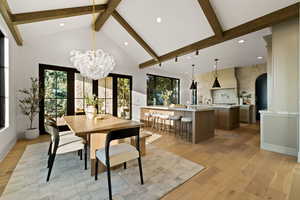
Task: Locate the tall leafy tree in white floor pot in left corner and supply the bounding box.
[18,77,41,139]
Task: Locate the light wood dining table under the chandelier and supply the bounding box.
[61,115,141,176]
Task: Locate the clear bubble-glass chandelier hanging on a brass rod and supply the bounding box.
[70,0,116,80]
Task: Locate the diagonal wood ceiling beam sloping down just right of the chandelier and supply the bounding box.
[112,10,158,61]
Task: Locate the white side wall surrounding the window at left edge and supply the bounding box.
[0,16,18,161]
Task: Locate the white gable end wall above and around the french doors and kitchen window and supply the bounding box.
[15,27,189,136]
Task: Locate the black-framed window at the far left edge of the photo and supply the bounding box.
[0,31,8,129]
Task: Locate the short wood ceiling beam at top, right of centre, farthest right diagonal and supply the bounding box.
[198,0,223,37]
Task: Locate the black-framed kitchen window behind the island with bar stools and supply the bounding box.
[147,74,180,105]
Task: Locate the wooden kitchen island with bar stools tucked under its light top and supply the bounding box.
[140,106,215,144]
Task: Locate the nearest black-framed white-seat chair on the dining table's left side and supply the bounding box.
[44,120,87,182]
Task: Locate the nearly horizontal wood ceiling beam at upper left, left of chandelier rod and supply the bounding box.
[12,4,107,24]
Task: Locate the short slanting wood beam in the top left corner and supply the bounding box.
[0,0,23,46]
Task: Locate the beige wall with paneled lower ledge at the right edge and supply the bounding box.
[261,19,299,156]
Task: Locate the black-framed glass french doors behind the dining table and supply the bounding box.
[39,64,132,133]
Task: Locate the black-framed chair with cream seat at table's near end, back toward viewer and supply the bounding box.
[95,128,144,200]
